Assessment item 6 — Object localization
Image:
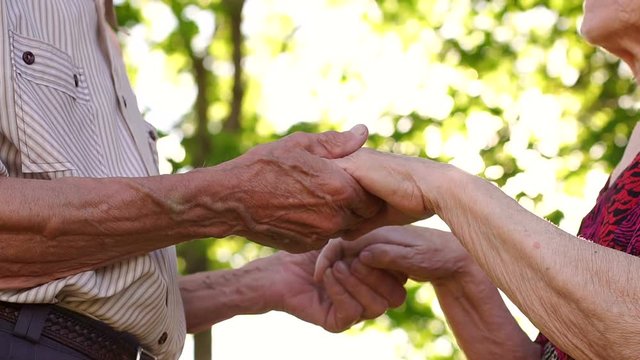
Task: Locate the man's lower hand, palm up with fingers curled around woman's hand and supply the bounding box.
[272,251,406,332]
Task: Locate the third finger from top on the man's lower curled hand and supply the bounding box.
[332,261,389,319]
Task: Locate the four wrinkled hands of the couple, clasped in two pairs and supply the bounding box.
[238,126,469,332]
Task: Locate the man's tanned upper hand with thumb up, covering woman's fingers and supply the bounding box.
[227,125,382,252]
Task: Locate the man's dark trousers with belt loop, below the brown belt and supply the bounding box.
[0,305,90,360]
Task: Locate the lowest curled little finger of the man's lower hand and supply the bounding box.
[322,269,363,332]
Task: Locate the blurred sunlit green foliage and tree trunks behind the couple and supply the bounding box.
[116,0,638,360]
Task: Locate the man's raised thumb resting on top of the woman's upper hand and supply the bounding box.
[308,124,369,159]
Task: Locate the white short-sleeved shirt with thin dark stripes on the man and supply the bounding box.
[0,0,185,359]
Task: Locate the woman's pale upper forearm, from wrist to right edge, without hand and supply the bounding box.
[438,172,640,359]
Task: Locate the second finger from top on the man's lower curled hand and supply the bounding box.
[351,259,407,307]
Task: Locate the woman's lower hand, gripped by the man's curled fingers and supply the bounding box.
[314,226,473,283]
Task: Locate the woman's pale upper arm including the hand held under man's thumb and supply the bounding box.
[341,151,640,359]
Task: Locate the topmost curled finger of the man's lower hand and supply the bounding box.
[358,244,416,275]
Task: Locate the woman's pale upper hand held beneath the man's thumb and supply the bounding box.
[334,149,454,239]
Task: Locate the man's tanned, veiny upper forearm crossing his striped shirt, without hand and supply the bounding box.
[0,166,244,289]
